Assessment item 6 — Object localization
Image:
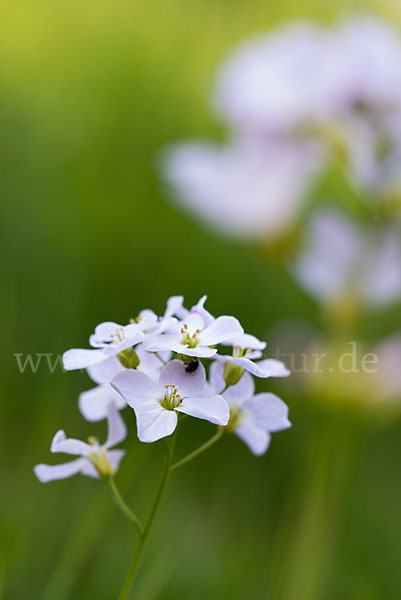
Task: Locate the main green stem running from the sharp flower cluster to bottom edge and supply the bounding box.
[119,433,176,600]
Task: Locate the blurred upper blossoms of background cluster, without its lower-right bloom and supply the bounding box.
[164,17,401,239]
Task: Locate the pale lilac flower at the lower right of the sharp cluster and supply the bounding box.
[209,363,291,455]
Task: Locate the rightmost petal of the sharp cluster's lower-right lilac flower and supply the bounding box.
[244,392,291,432]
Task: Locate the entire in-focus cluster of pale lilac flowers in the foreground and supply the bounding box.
[35,296,290,481]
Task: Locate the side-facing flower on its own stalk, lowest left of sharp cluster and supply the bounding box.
[34,404,127,483]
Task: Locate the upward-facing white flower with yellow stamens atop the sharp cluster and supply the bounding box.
[143,313,243,358]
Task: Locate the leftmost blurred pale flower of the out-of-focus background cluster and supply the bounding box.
[164,140,321,237]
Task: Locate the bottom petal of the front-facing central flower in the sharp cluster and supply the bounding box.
[134,401,177,443]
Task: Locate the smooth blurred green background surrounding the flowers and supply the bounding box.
[0,0,401,600]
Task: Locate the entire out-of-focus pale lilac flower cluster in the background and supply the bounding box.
[163,16,401,414]
